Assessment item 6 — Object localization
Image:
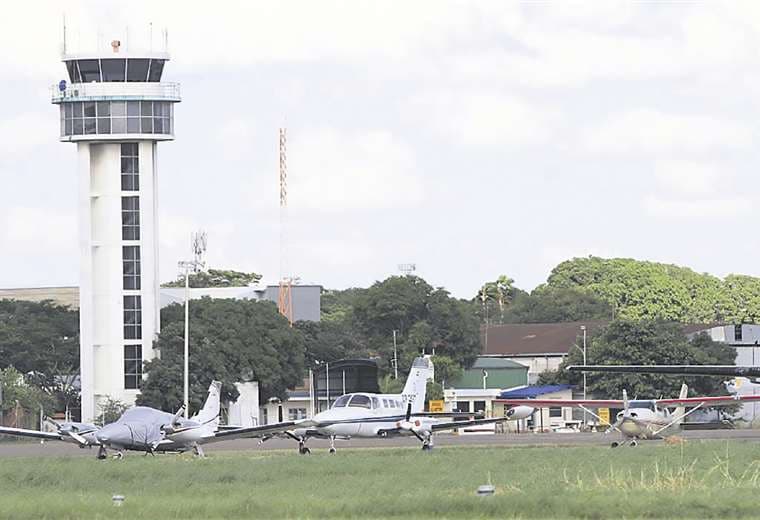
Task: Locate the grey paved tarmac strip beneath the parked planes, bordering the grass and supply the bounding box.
[0,430,760,459]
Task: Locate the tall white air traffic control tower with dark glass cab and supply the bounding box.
[52,41,180,421]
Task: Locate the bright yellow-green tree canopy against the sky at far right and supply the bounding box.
[548,257,760,323]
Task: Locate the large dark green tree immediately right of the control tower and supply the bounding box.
[138,298,305,410]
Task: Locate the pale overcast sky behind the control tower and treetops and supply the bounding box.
[0,0,760,297]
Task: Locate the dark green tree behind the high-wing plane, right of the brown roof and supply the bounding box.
[539,320,736,399]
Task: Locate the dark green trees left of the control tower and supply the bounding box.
[0,300,79,412]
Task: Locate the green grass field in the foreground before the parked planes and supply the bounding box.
[0,441,760,520]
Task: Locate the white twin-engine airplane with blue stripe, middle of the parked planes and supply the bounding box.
[242,356,510,455]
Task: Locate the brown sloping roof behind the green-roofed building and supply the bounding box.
[480,321,607,356]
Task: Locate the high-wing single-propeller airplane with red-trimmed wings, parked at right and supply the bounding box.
[503,385,760,448]
